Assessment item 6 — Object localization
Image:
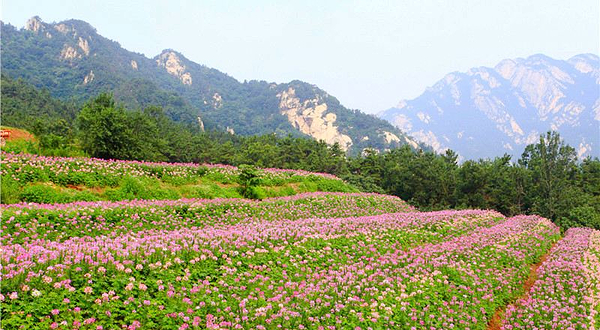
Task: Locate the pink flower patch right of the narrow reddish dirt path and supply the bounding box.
[502,228,600,330]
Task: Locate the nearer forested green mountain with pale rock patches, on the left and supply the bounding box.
[2,16,424,154]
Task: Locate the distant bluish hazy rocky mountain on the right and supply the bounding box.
[379,54,600,159]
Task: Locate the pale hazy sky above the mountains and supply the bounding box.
[1,0,600,113]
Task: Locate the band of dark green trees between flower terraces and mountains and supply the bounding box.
[3,90,600,229]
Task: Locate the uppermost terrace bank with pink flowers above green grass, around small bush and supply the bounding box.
[1,154,357,204]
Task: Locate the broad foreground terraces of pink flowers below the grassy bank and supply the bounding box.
[0,155,600,329]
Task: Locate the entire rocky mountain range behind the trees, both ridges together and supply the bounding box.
[2,17,600,159]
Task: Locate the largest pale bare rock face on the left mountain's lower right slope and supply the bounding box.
[277,87,352,151]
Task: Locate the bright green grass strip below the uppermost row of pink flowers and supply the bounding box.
[1,165,358,204]
